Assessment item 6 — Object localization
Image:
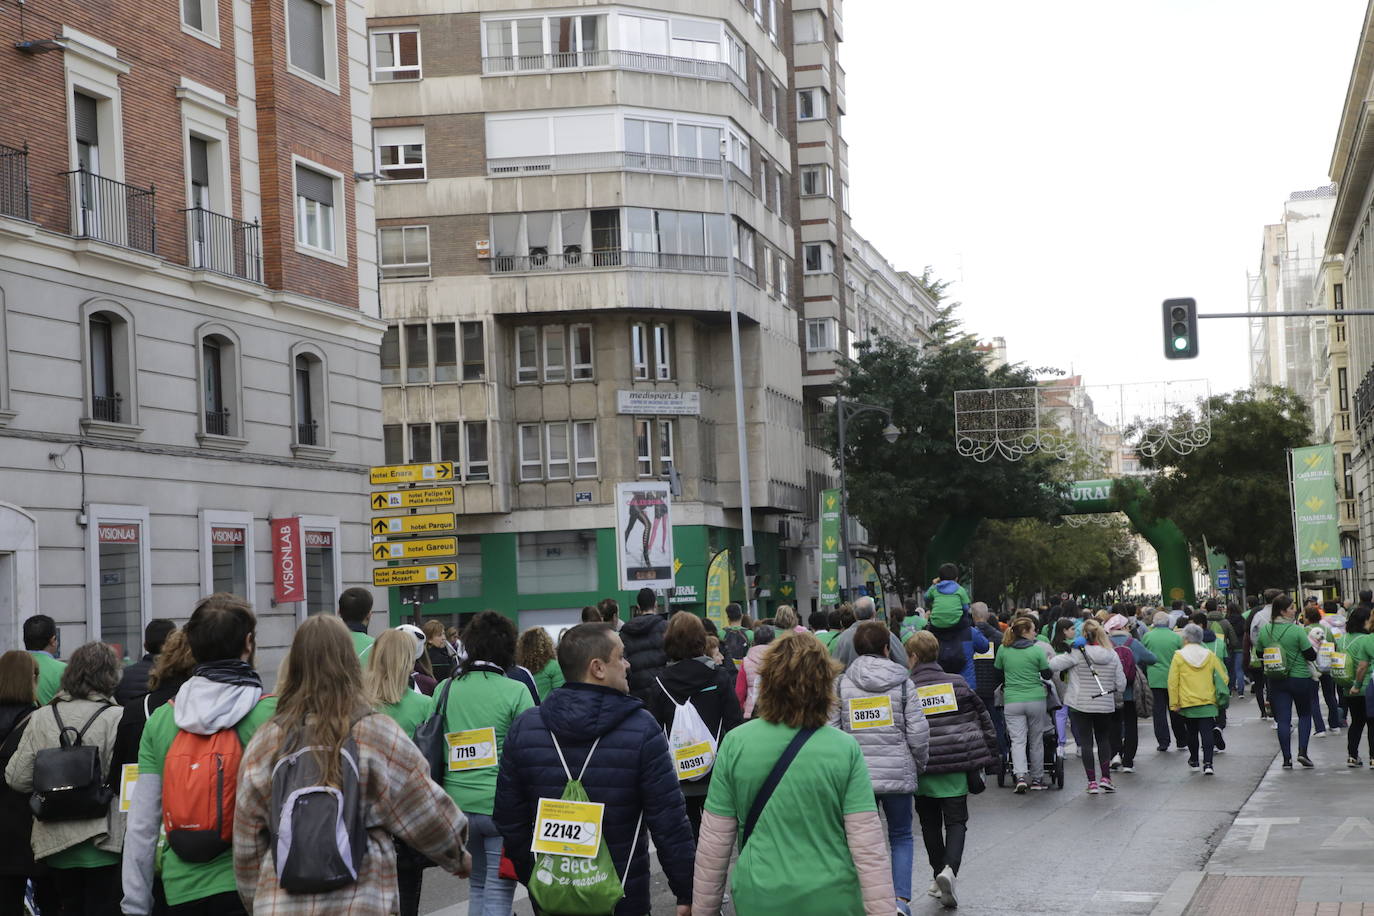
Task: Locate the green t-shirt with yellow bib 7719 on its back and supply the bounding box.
[434,669,534,814]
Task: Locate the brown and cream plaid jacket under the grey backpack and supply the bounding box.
[234,715,467,916]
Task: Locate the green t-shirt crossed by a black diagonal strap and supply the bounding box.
[706,718,877,916]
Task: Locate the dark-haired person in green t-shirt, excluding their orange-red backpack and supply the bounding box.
[122,595,276,916]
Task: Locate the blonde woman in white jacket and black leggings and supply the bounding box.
[1050,619,1125,795]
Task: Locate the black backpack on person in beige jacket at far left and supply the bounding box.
[29,703,118,821]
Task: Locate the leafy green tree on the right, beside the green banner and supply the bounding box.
[1136,387,1312,592]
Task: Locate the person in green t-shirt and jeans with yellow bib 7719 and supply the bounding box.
[434,611,534,913]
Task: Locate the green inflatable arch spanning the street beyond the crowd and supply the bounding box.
[926,478,1195,604]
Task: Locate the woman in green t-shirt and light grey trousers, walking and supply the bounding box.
[992,617,1050,795]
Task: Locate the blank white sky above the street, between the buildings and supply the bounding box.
[840,0,1364,393]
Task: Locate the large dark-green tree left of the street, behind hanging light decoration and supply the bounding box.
[829,304,1059,595]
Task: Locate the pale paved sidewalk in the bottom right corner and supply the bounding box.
[1151,721,1374,916]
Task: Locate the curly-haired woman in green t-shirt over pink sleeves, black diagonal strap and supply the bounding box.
[692,633,896,916]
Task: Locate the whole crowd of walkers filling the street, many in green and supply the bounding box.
[0,585,1374,916]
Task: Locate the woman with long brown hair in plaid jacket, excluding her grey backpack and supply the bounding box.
[234,614,470,913]
